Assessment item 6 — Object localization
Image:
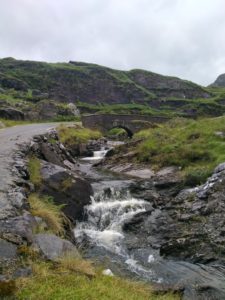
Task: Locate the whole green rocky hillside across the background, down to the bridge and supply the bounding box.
[0,58,225,121]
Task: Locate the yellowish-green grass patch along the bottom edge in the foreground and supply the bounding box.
[16,259,180,300]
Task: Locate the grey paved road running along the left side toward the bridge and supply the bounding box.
[0,123,59,219]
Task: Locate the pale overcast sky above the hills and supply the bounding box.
[0,0,225,85]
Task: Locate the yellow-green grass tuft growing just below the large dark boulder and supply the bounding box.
[28,194,65,236]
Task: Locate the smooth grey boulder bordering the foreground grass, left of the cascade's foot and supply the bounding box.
[33,234,78,260]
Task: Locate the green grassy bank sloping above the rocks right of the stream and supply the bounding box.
[135,116,225,185]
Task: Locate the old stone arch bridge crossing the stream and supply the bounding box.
[81,114,170,137]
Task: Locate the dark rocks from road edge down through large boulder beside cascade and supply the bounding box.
[30,131,93,223]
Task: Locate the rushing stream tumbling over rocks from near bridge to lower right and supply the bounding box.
[74,145,225,300]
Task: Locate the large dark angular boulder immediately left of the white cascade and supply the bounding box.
[41,162,93,223]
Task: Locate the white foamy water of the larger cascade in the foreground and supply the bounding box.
[74,189,149,258]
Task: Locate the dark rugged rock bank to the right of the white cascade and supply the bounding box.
[124,164,225,264]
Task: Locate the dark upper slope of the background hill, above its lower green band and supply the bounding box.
[0,58,209,104]
